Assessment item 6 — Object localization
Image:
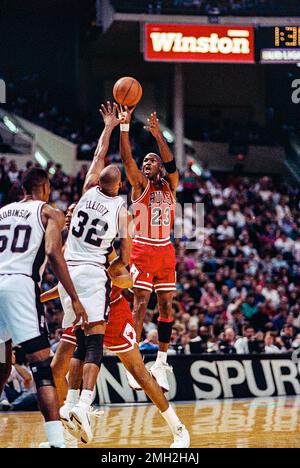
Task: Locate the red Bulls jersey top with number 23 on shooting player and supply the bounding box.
[133,179,176,245]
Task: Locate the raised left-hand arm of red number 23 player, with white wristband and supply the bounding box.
[120,107,148,190]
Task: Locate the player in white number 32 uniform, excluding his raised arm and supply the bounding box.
[59,107,132,442]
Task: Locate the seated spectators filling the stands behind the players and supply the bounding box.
[0,152,300,354]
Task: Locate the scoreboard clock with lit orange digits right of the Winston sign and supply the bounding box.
[255,26,300,63]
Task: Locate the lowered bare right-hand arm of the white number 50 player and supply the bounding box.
[42,205,88,325]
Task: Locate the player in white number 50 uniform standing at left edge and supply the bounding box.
[0,168,87,448]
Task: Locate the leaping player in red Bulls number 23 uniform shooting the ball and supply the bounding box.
[120,107,179,391]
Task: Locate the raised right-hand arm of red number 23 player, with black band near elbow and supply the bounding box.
[144,112,179,192]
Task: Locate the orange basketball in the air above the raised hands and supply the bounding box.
[113,76,143,107]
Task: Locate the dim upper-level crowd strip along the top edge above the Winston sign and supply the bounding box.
[112,0,299,16]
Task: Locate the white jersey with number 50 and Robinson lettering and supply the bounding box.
[0,201,46,283]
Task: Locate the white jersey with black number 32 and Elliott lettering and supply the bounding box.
[65,187,124,266]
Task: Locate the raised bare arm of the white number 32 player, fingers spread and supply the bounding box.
[83,101,121,193]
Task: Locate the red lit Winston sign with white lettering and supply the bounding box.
[144,24,255,63]
